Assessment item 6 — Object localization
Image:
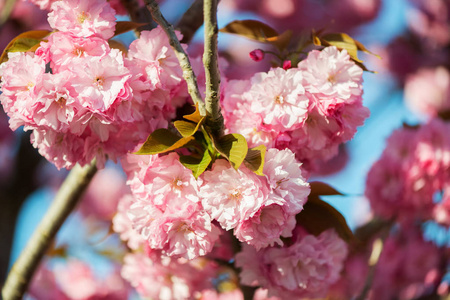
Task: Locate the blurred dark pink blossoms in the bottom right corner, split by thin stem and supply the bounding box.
[330,224,446,300]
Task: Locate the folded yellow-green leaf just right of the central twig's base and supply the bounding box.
[212,133,248,170]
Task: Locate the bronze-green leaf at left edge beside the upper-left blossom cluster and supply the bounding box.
[0,30,51,63]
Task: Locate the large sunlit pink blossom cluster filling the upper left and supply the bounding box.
[0,0,186,168]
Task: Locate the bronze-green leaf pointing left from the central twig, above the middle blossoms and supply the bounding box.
[134,128,194,155]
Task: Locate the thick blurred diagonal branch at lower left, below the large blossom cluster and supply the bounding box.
[2,160,97,300]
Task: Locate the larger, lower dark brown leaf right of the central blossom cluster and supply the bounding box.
[296,195,355,242]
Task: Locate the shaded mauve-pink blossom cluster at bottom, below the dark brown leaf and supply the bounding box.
[236,230,348,299]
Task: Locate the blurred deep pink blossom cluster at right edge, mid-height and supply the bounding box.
[366,119,450,224]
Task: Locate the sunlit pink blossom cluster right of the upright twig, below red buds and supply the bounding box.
[222,47,369,169]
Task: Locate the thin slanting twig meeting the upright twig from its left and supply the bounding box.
[144,0,206,116]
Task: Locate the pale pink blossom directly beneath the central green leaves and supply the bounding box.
[199,160,268,230]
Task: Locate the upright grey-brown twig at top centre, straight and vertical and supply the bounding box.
[203,0,223,136]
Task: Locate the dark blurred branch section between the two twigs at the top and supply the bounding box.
[175,0,203,44]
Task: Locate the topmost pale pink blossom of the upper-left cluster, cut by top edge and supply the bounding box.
[48,0,116,40]
